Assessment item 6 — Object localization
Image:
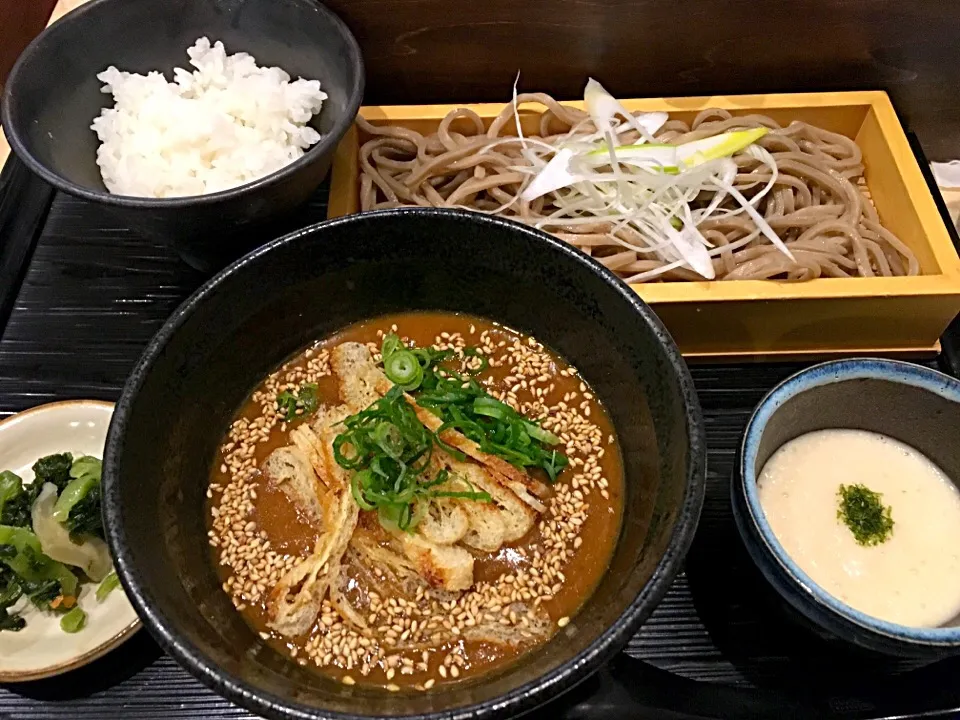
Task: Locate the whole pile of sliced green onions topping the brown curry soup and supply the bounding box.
[333,333,568,532]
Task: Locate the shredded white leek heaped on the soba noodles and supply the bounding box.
[502,79,794,282]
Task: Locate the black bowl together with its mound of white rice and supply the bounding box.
[2,0,364,270]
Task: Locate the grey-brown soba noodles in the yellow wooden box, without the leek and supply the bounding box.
[357,93,920,282]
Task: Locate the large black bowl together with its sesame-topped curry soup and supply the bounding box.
[104,209,705,718]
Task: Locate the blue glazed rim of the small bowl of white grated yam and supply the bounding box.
[732,357,960,649]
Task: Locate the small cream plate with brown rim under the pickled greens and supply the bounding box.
[0,400,140,682]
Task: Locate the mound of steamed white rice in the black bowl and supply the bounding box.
[91,37,327,197]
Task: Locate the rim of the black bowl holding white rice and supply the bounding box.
[0,0,366,210]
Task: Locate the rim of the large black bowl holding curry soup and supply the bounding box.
[103,207,706,720]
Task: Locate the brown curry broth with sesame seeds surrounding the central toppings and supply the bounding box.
[206,312,623,690]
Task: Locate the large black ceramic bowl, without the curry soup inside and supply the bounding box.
[103,209,705,718]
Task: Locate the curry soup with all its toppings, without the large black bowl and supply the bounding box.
[206,312,624,691]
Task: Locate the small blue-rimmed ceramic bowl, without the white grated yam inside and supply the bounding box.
[732,359,960,658]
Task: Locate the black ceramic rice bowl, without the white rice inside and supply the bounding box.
[0,0,364,270]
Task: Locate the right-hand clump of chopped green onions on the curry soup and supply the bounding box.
[381,333,569,482]
